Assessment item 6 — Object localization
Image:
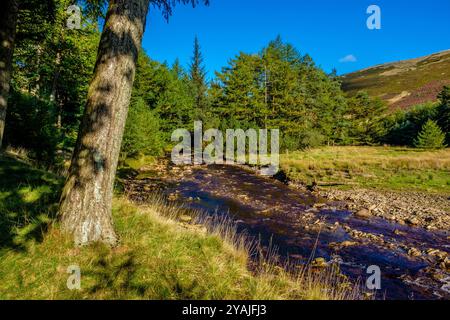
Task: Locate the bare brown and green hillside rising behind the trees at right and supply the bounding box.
[342,50,450,109]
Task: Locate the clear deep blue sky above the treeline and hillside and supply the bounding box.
[143,0,450,77]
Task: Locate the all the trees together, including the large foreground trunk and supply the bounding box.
[0,0,450,246]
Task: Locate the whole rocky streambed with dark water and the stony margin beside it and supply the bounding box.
[124,163,450,299]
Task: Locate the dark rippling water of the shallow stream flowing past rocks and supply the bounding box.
[166,166,450,299]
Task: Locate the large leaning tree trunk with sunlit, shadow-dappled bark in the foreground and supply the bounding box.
[59,0,149,245]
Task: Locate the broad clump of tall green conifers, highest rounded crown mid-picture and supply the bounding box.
[209,37,347,149]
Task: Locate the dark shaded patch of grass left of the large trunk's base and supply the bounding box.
[0,154,63,251]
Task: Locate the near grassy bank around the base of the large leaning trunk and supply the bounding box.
[0,155,358,299]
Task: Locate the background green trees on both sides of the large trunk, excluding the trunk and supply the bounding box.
[5,0,450,164]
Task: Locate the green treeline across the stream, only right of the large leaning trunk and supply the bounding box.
[122,37,450,156]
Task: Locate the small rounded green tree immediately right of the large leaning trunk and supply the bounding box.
[121,99,163,158]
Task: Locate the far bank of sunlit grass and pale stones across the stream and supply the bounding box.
[281,147,450,231]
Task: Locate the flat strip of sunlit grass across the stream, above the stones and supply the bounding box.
[281,147,450,194]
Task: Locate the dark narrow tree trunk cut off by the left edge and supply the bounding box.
[0,0,19,148]
